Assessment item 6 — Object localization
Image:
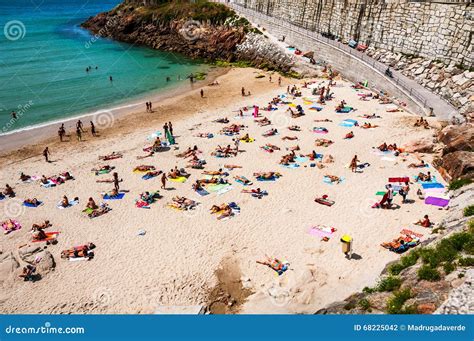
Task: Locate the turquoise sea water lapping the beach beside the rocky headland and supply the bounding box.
[0,0,207,135]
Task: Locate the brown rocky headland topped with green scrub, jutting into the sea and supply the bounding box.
[82,1,293,72]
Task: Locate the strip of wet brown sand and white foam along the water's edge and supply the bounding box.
[0,65,226,157]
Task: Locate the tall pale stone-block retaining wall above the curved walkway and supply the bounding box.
[231,0,474,67]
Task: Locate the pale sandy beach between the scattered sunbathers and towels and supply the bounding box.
[0,68,444,314]
